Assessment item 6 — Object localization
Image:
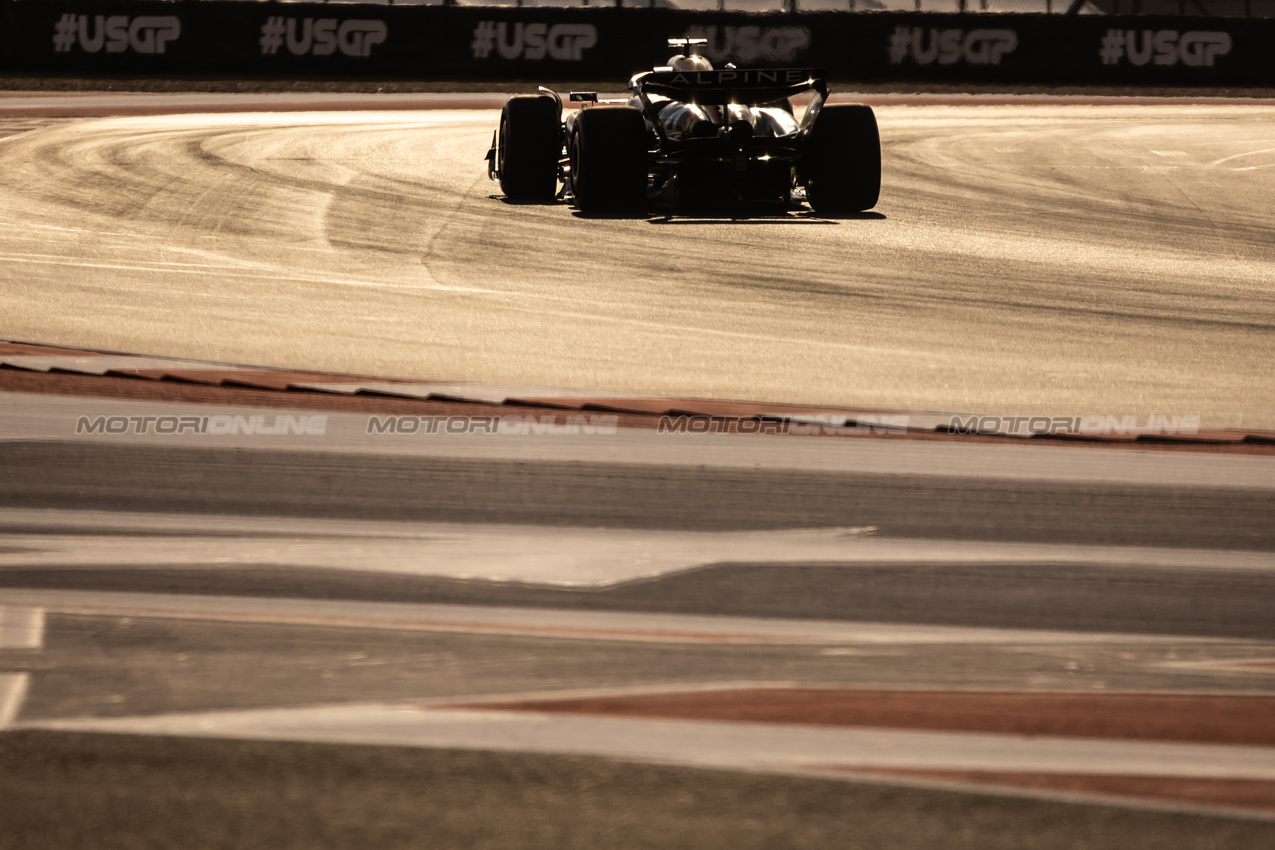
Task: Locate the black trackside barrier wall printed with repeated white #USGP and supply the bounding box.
[0,0,1275,85]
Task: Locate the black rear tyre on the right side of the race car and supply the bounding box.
[806,103,881,215]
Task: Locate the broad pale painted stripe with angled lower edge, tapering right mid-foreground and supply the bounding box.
[0,524,887,587]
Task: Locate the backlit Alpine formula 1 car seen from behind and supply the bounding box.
[487,40,881,215]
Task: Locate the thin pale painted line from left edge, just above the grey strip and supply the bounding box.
[5,589,1203,646]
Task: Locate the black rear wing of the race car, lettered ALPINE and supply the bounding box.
[632,68,827,106]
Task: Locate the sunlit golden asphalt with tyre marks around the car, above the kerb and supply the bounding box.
[0,96,1275,428]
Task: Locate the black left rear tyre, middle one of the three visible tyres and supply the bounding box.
[570,106,648,213]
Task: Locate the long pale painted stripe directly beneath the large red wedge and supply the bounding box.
[24,705,1275,781]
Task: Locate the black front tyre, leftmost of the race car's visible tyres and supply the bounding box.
[496,94,562,200]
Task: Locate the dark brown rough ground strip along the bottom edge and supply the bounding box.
[9,731,1275,850]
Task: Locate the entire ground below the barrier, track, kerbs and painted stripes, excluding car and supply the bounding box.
[0,96,1275,850]
